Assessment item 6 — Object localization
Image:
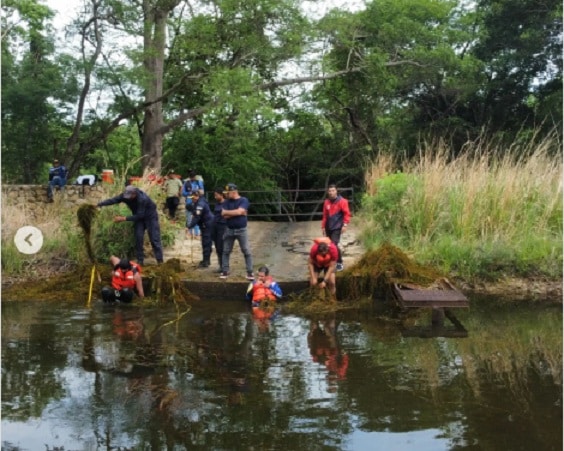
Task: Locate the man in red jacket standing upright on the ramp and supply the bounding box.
[321,185,351,271]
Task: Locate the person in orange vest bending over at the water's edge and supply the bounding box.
[307,237,339,295]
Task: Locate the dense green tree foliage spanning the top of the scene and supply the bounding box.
[2,0,562,198]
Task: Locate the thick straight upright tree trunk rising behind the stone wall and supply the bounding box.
[141,0,170,173]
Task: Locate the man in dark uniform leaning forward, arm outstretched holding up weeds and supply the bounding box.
[98,185,163,265]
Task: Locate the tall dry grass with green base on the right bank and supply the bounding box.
[362,129,562,277]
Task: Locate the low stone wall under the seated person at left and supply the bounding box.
[2,183,113,219]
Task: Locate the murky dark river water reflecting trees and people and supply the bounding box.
[1,299,562,451]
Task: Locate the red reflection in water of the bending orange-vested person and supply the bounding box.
[307,318,349,385]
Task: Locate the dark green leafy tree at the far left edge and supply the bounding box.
[2,1,62,183]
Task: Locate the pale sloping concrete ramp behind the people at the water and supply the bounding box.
[159,221,364,281]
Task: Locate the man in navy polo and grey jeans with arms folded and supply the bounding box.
[219,183,254,280]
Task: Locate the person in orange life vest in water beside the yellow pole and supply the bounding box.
[102,255,145,303]
